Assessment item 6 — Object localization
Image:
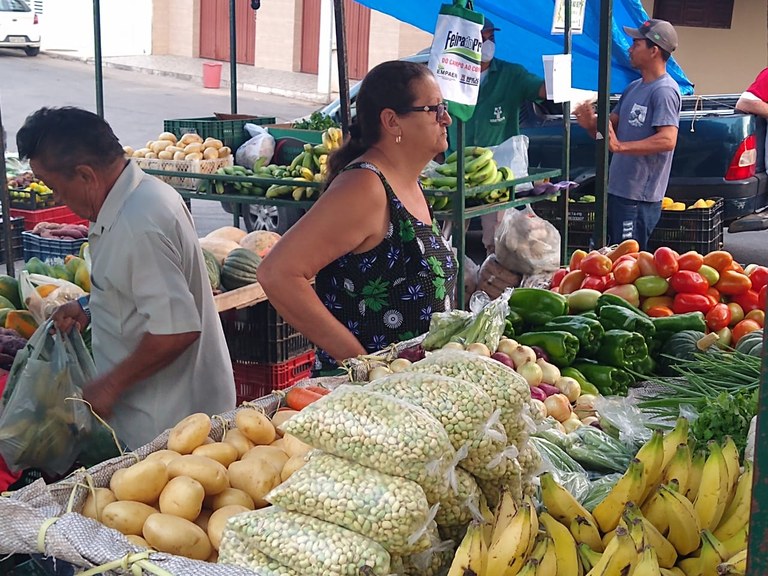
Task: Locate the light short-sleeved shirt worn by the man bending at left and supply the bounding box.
[88,162,235,449]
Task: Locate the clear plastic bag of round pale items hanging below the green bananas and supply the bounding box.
[496,205,560,274]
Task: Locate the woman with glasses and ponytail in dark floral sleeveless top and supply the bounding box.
[258,61,457,366]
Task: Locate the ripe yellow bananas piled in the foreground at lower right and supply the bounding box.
[449,418,753,576]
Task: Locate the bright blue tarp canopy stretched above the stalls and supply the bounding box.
[357,0,693,94]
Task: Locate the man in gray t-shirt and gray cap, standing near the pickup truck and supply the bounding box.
[574,20,682,250]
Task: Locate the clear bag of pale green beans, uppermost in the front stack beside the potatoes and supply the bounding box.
[280,385,458,504]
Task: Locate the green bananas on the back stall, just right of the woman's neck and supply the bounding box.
[421,146,514,210]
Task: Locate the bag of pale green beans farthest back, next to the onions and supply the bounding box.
[406,350,531,438]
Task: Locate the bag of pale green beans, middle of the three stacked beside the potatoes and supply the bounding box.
[266,450,436,555]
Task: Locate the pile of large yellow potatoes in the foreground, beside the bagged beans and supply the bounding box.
[81,407,311,562]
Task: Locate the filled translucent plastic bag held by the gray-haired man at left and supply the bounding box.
[0,322,95,475]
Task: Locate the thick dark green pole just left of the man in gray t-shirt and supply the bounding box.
[595,0,613,248]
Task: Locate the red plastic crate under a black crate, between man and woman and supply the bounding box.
[232,350,315,404]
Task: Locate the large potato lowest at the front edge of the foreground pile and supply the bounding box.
[142,514,211,560]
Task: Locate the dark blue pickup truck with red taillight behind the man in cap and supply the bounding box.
[520,94,768,223]
